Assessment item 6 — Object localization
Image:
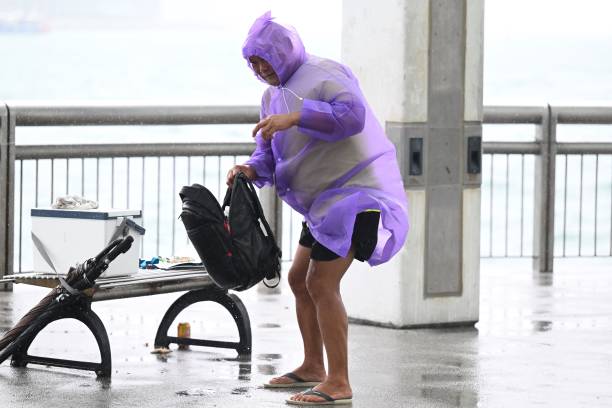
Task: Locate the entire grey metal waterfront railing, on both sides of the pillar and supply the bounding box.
[0,105,612,286]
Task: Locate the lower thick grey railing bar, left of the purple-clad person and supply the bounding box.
[15,143,255,160]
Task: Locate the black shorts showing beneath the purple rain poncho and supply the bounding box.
[300,211,380,262]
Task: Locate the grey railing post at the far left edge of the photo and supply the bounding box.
[0,104,15,291]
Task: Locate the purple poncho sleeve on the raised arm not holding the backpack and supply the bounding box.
[298,78,366,142]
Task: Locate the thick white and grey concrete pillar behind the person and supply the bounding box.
[342,0,484,327]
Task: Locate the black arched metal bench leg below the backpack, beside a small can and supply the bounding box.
[155,289,252,355]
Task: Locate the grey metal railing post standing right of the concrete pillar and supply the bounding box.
[533,105,557,272]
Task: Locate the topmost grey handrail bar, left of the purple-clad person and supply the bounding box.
[9,104,259,126]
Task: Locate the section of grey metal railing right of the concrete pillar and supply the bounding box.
[481,106,612,271]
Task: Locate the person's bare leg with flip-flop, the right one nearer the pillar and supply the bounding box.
[291,253,353,402]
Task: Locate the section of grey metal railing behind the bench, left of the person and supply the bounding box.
[0,105,277,286]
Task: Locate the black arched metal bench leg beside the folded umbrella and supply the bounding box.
[11,300,112,377]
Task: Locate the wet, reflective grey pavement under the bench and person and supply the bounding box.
[0,258,612,408]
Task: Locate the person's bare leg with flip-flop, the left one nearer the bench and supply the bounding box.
[270,245,325,384]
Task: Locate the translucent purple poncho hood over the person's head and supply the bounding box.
[242,11,307,85]
